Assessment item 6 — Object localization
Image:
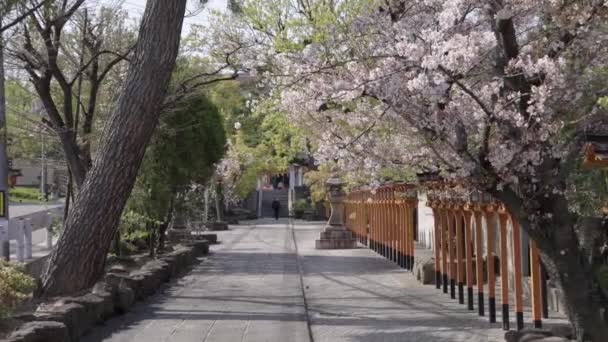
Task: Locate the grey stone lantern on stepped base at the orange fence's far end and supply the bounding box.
[315,176,357,249]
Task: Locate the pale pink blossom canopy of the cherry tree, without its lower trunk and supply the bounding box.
[249,0,608,192]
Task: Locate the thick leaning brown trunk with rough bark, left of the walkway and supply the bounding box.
[42,0,186,296]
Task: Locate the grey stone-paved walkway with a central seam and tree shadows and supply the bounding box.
[83,220,548,342]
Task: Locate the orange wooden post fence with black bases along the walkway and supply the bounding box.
[345,182,546,330]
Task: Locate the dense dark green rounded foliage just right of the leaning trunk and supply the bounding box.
[129,93,226,221]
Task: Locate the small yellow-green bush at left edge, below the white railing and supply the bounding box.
[0,260,36,319]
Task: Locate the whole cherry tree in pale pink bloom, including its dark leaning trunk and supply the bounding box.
[217,0,608,341]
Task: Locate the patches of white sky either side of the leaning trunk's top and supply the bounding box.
[95,0,227,34]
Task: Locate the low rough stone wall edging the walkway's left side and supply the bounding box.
[4,241,209,342]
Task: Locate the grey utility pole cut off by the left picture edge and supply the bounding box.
[0,13,11,260]
